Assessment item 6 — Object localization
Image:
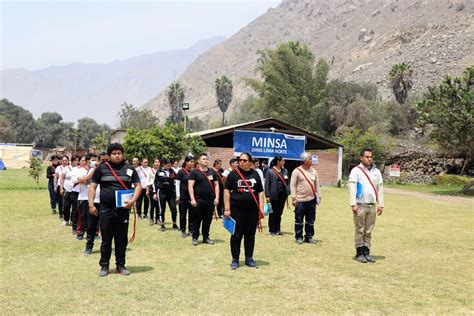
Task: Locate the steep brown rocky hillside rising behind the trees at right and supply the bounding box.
[145,0,474,122]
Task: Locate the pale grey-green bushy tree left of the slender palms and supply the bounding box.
[117,102,158,130]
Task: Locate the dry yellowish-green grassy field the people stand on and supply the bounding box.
[0,170,474,315]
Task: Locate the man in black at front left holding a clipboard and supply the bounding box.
[89,143,142,276]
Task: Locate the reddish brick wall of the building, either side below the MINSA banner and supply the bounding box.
[207,147,337,185]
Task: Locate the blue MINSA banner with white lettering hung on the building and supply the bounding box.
[234,130,306,160]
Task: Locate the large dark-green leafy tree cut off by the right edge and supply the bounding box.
[416,66,474,174]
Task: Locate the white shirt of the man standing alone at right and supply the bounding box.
[349,164,383,206]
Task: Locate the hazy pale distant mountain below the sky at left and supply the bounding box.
[0,37,225,125]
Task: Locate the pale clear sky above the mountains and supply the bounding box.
[0,0,281,71]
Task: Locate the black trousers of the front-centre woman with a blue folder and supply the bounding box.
[230,205,258,259]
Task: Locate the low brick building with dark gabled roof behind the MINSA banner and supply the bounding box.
[191,118,343,185]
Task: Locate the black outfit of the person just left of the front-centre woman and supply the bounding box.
[189,168,219,241]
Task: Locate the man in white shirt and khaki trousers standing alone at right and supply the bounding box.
[349,148,384,263]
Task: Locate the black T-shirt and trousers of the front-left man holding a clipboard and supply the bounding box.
[92,162,140,267]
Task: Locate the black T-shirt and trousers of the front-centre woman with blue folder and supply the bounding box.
[225,169,263,259]
